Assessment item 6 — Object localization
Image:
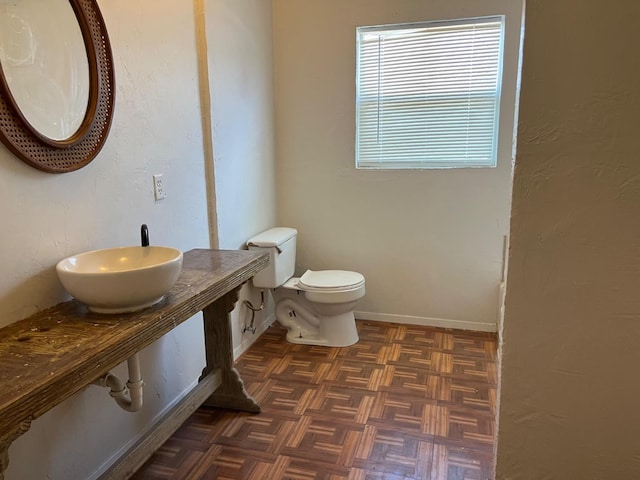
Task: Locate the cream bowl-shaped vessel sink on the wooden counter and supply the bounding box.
[56,245,182,313]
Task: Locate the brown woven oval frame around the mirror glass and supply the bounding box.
[0,0,115,173]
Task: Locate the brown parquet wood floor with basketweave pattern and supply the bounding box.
[133,321,497,480]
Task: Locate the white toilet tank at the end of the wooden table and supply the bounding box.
[247,227,298,288]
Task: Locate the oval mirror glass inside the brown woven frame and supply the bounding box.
[0,0,89,140]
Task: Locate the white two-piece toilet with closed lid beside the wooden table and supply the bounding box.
[247,227,365,347]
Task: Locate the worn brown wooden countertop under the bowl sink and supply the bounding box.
[0,249,269,444]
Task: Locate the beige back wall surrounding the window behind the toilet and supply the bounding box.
[273,0,522,330]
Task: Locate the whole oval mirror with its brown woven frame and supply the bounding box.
[0,0,115,173]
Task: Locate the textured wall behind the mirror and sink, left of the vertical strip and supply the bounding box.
[0,0,220,480]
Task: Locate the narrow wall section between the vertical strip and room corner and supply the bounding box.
[204,0,276,353]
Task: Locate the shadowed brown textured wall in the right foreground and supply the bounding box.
[497,0,640,480]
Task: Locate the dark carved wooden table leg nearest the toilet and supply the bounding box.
[200,287,260,412]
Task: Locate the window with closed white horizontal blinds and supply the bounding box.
[356,16,504,169]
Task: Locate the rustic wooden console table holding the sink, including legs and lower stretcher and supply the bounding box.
[0,249,269,480]
